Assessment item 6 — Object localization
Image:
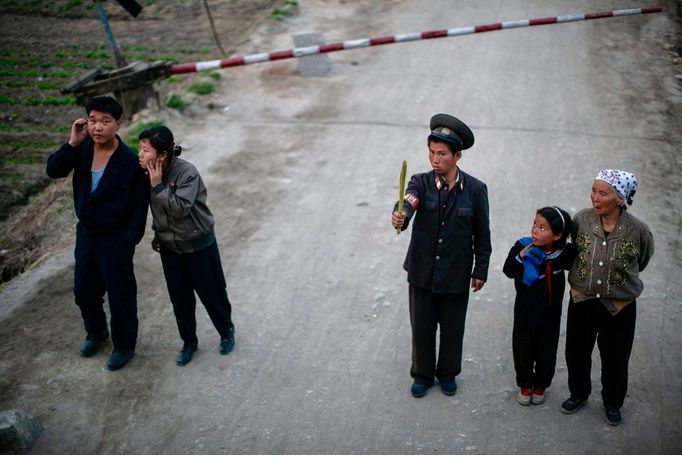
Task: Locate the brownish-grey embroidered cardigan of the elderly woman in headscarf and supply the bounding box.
[568,209,654,302]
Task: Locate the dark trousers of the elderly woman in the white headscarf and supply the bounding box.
[566,299,637,408]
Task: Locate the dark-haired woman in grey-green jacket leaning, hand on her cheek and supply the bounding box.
[139,126,234,366]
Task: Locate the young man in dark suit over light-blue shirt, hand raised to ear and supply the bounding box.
[47,96,149,371]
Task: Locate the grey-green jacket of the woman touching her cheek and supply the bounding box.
[151,157,215,253]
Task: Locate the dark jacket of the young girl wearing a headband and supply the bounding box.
[502,241,575,324]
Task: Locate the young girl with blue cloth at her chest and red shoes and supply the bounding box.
[503,207,575,406]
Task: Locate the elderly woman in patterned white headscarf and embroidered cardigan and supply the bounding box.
[561,169,654,425]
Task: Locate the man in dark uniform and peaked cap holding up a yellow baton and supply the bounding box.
[391,114,492,398]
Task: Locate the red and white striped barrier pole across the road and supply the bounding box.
[171,6,661,74]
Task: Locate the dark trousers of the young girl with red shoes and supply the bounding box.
[512,319,561,389]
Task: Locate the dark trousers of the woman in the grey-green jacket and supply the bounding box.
[161,242,232,344]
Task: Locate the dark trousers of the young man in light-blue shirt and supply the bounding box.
[73,225,138,351]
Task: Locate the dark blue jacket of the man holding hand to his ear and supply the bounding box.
[47,136,149,244]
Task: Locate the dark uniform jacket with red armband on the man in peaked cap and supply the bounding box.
[403,170,492,294]
